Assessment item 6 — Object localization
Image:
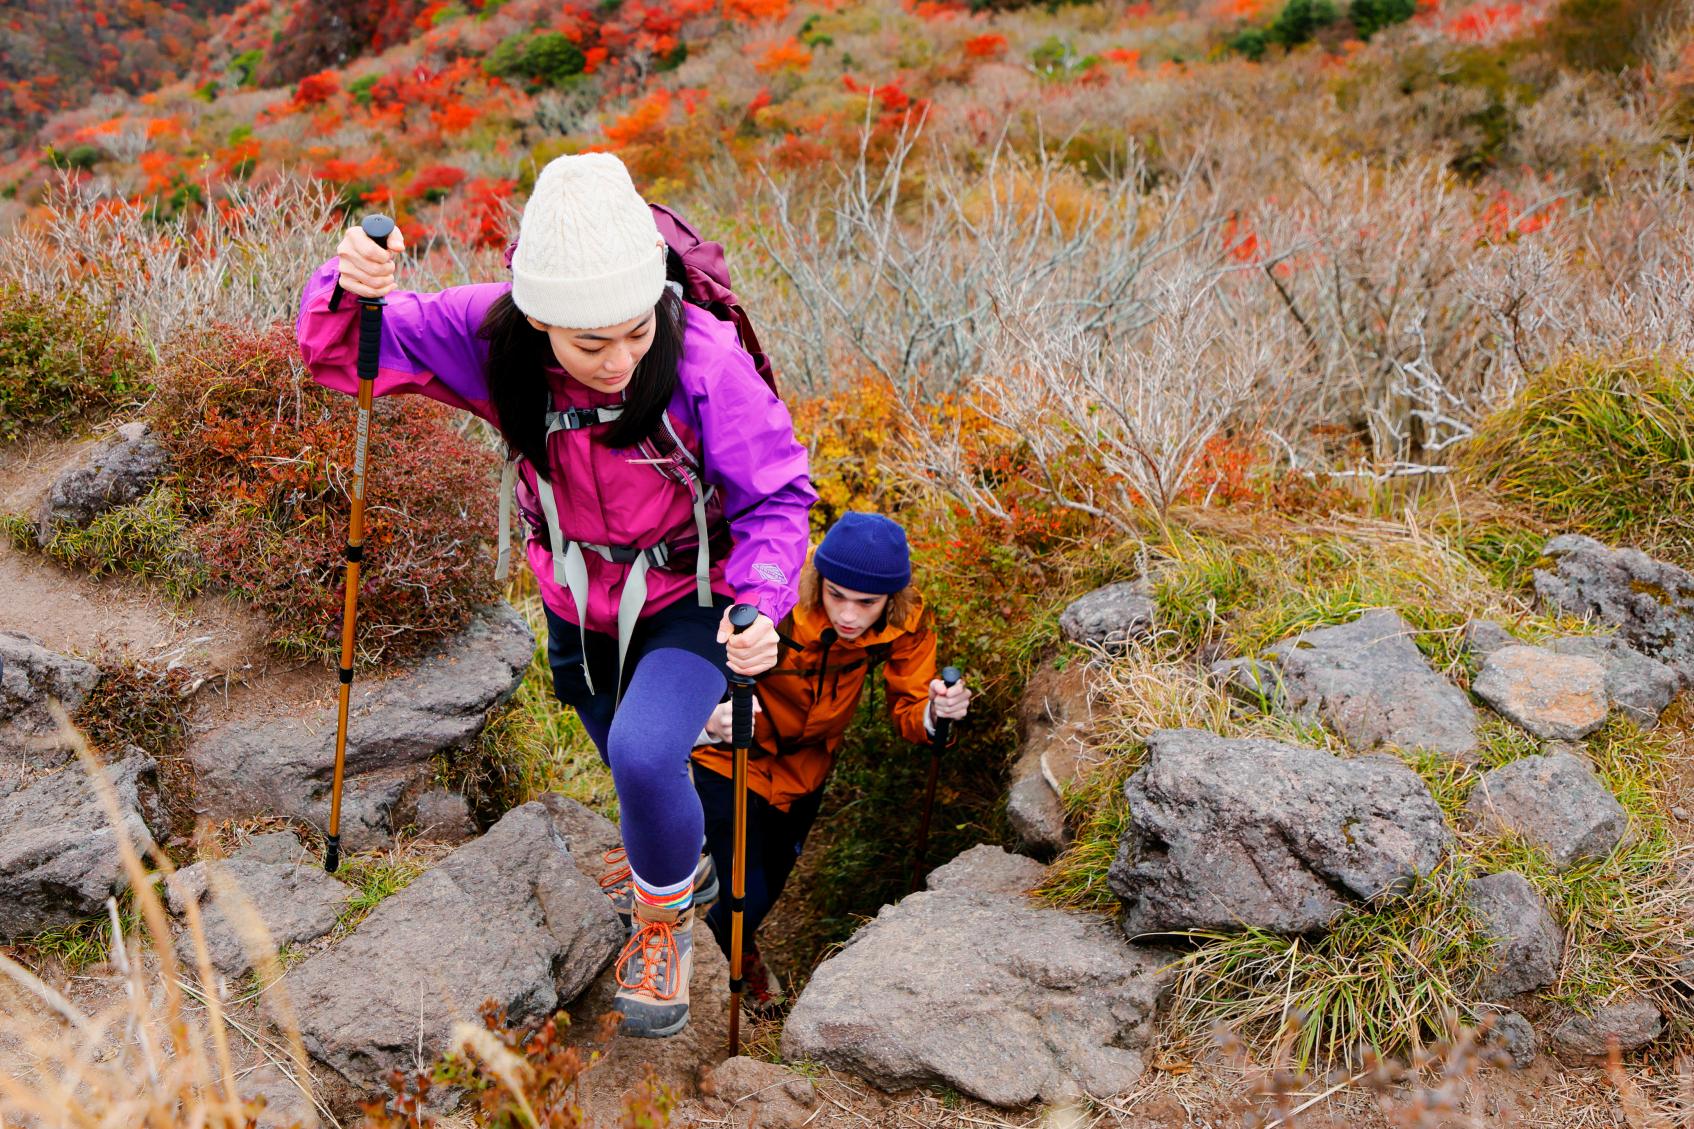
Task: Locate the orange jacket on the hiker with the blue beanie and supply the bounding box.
[695,576,935,810]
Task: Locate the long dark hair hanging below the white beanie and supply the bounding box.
[476,261,686,473]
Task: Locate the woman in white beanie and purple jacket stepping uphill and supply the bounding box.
[298,153,817,1037]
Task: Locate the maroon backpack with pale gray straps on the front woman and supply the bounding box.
[495,203,781,697]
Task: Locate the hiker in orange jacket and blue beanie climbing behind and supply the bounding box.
[695,512,971,1014]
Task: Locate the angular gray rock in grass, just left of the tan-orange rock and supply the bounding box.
[1267,609,1477,758]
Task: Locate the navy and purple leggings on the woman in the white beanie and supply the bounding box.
[547,598,728,892]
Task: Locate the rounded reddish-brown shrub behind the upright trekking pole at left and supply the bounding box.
[149,325,496,658]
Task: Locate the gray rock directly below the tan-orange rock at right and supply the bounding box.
[1465,753,1630,870]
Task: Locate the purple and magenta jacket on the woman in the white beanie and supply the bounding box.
[296,259,817,637]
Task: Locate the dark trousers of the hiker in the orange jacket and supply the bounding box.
[695,765,823,956]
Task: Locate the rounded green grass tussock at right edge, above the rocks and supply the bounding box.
[1460,356,1694,563]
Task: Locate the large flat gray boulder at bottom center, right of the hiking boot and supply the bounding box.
[783,861,1160,1105]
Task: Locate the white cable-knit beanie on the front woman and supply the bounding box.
[512,153,664,329]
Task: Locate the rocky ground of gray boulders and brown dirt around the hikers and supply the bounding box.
[0,417,1694,1127]
